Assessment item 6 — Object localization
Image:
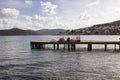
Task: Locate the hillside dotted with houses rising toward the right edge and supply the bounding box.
[61,20,120,35]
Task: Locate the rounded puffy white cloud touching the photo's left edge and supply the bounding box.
[0,8,19,18]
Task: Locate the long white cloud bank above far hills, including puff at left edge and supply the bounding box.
[0,8,65,30]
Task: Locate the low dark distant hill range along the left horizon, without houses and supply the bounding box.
[0,28,65,36]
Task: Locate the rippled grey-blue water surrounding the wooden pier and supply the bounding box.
[0,35,120,80]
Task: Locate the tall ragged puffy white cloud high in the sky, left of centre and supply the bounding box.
[40,1,58,15]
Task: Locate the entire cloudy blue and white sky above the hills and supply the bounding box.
[0,0,120,30]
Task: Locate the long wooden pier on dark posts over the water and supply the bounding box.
[30,40,120,51]
